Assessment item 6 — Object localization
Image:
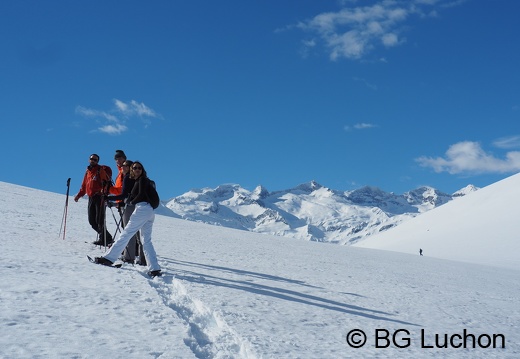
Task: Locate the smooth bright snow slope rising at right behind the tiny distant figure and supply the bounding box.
[356,174,520,269]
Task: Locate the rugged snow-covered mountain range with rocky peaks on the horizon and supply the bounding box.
[165,181,477,244]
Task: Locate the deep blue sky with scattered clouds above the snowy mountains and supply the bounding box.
[0,0,520,199]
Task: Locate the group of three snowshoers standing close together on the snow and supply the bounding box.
[74,150,161,277]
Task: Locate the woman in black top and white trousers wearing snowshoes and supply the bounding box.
[94,161,162,277]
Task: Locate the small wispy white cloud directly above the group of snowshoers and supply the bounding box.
[76,99,160,135]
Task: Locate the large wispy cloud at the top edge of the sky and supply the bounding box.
[287,0,464,61]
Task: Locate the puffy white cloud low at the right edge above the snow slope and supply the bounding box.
[416,141,520,174]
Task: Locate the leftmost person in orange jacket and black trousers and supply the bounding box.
[74,153,114,246]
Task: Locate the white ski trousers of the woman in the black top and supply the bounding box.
[105,202,161,271]
